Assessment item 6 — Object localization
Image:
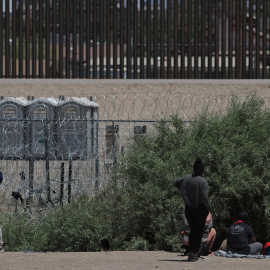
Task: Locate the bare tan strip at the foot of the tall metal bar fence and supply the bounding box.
[0,79,270,98]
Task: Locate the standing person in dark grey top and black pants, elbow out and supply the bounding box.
[174,158,210,261]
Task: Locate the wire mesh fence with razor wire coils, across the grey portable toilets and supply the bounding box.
[0,93,268,211]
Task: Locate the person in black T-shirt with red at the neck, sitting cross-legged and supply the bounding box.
[226,212,263,255]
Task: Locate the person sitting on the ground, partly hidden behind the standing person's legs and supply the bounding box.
[182,213,217,256]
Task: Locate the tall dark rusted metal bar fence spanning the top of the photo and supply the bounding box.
[0,0,270,79]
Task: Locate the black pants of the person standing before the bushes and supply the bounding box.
[185,205,209,253]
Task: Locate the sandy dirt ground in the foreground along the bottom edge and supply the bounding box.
[0,251,269,270]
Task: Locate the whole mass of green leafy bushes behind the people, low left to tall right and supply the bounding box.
[1,95,270,251]
